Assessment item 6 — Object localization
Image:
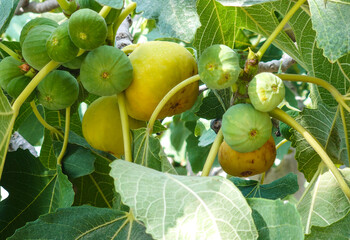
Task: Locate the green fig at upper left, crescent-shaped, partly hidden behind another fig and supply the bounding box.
[22,25,55,70]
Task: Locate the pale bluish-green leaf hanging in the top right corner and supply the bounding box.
[308,0,350,62]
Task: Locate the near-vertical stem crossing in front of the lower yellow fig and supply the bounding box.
[117,92,132,162]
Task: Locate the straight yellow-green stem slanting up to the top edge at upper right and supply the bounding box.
[257,0,306,60]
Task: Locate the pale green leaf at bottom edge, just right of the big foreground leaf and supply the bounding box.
[248,198,304,240]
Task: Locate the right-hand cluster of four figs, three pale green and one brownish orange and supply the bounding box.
[198,44,285,177]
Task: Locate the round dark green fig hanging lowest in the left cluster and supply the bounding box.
[37,70,79,110]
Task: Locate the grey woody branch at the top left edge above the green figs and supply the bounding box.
[15,0,60,15]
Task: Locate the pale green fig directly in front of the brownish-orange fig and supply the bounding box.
[221,103,272,152]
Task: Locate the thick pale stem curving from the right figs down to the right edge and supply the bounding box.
[269,108,350,200]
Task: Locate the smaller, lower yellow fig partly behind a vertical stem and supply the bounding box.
[82,95,146,157]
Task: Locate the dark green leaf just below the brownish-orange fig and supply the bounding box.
[229,173,299,199]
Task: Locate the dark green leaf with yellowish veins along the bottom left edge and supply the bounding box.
[9,206,152,240]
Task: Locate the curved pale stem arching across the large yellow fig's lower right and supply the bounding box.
[147,74,200,135]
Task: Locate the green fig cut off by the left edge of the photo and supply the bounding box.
[0,56,25,91]
